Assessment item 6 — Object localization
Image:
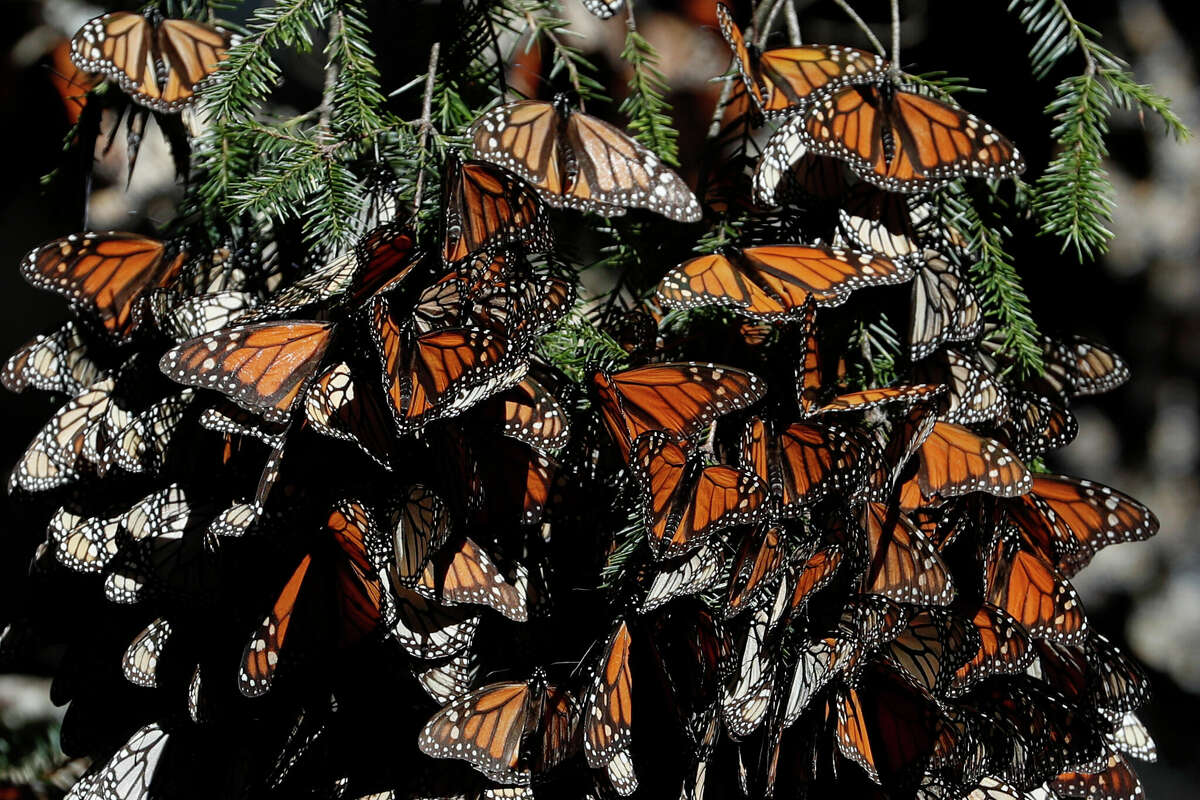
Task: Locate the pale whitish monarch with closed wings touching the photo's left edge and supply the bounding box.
[0,321,103,396]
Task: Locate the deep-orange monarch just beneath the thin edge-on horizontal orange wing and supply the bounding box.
[742,417,866,517]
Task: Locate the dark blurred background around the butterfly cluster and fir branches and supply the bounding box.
[0,0,1200,800]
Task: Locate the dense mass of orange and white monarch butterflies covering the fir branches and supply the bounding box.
[0,2,1158,800]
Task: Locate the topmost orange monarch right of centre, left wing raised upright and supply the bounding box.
[716,2,888,116]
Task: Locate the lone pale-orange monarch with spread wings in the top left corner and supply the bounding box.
[71,11,232,114]
